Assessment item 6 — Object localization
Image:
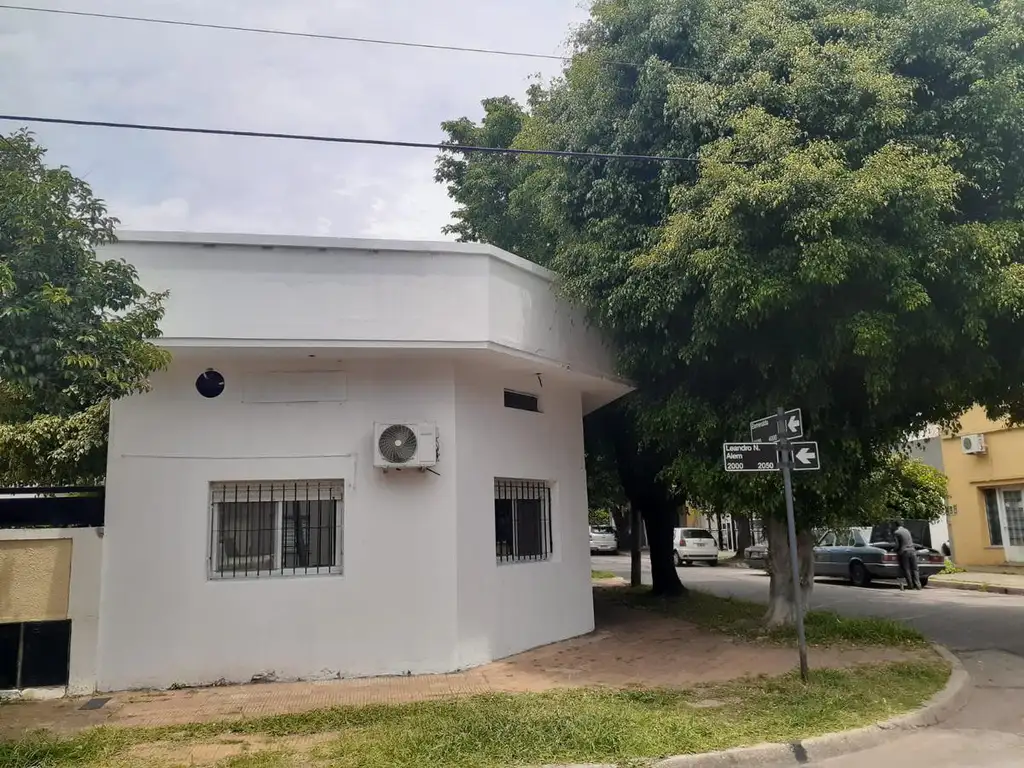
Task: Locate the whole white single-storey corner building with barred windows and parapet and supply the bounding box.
[95,232,630,690]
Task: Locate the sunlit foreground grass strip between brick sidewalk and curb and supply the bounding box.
[0,658,948,768]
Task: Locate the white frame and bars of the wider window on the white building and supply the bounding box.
[207,479,345,582]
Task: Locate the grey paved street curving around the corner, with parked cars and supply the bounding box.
[592,554,1024,768]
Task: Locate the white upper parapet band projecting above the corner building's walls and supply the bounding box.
[99,231,625,385]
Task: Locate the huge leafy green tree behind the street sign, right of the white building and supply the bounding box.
[438,0,1024,623]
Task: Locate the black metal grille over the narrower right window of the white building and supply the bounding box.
[495,478,554,562]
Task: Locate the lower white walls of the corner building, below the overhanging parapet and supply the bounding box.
[98,354,593,690]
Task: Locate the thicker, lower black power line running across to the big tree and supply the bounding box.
[0,115,697,163]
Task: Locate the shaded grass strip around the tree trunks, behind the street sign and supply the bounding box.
[594,587,927,648]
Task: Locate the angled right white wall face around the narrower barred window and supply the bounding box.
[456,367,594,666]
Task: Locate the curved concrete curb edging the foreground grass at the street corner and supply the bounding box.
[545,645,971,768]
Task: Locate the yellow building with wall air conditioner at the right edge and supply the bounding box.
[942,408,1024,565]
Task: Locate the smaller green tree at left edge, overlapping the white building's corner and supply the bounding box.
[0,131,166,485]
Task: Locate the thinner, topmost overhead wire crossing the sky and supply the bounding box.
[0,3,698,72]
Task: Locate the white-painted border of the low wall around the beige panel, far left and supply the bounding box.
[0,528,103,697]
